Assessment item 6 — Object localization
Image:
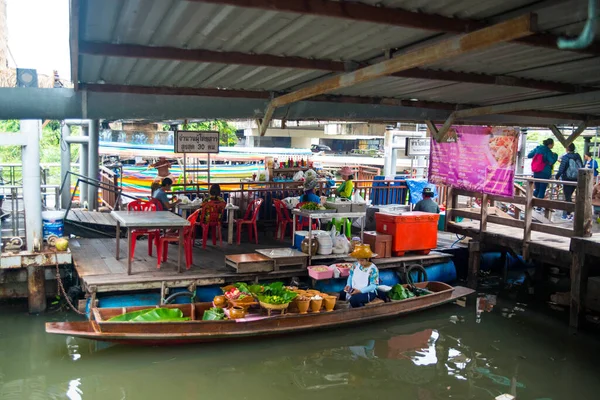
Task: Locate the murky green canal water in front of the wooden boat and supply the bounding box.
[0,296,600,400]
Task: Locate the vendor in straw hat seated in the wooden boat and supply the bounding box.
[340,245,379,308]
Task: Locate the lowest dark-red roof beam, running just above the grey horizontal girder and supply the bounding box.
[81,83,588,121]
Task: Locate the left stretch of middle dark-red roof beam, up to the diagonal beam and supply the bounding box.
[79,42,346,72]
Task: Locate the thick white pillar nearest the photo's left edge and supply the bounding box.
[21,120,42,251]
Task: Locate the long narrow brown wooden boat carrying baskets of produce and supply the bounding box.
[46,282,473,345]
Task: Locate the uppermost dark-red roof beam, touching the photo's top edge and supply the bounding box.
[188,0,600,55]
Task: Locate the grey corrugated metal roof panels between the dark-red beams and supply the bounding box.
[79,0,600,120]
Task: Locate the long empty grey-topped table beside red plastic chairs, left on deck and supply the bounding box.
[110,211,190,275]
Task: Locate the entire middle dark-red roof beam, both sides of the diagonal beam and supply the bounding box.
[79,41,598,93]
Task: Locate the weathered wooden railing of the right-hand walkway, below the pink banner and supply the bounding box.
[446,169,593,255]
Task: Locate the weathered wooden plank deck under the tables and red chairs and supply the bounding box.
[70,238,451,293]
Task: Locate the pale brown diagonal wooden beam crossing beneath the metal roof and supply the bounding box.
[261,14,536,135]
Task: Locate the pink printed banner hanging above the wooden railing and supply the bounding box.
[429,125,519,197]
